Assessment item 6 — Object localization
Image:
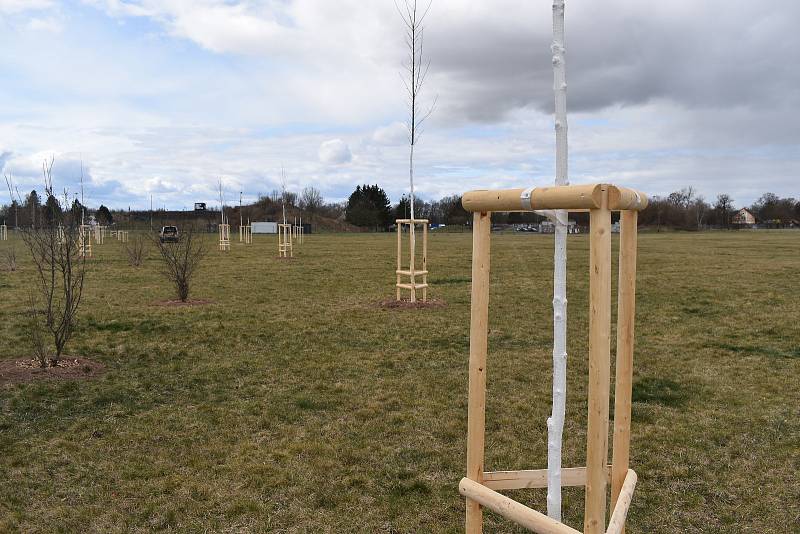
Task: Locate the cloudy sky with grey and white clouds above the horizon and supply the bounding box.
[0,0,800,209]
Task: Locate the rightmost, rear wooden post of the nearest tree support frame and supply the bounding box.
[611,211,638,528]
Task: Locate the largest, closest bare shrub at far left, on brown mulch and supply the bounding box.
[22,158,86,367]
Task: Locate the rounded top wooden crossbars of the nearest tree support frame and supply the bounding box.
[461,184,647,213]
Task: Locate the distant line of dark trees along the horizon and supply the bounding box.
[0,184,800,231]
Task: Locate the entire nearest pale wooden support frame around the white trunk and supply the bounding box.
[459,184,647,534]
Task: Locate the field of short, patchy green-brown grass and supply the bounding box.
[0,231,800,533]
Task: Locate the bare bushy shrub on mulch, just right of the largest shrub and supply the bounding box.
[153,228,206,302]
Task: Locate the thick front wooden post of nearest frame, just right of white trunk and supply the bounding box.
[583,191,611,534]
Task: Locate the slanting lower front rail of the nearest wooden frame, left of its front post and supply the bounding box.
[458,477,581,534]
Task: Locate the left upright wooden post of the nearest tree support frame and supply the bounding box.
[466,212,492,534]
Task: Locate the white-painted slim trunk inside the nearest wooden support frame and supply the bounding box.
[547,0,569,521]
